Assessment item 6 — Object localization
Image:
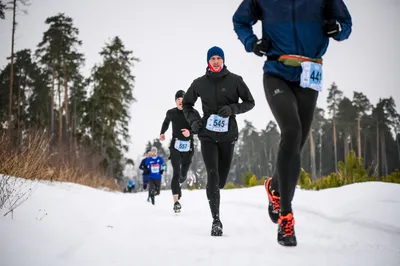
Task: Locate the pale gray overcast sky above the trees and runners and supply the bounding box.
[0,0,400,159]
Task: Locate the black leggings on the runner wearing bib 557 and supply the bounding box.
[169,147,193,195]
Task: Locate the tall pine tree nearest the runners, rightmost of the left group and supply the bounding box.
[84,37,139,177]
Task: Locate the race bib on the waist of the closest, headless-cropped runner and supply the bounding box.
[300,62,322,91]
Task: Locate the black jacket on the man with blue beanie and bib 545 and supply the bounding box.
[183,65,255,142]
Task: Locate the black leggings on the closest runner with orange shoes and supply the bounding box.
[264,74,318,214]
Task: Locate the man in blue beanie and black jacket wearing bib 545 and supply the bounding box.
[183,46,254,236]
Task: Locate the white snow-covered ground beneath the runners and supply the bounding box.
[0,179,400,266]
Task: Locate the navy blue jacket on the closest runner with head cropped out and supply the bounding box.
[233,0,352,81]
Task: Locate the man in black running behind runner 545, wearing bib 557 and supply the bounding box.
[160,90,197,212]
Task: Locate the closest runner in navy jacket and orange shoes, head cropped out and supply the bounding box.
[233,0,352,246]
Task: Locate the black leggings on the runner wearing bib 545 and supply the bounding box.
[201,141,235,219]
